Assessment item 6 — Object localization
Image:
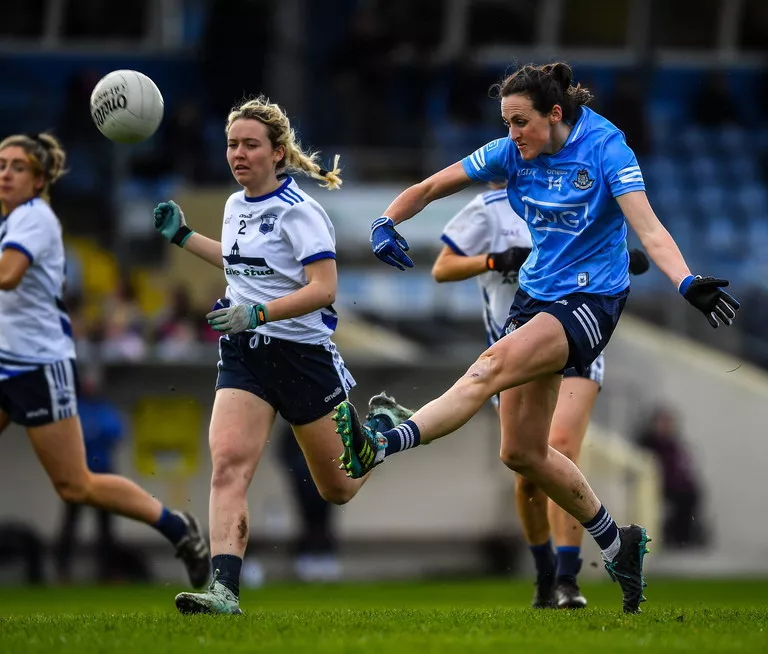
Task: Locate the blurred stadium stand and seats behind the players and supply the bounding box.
[0,0,768,596]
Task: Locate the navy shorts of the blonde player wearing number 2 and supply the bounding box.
[216,332,355,425]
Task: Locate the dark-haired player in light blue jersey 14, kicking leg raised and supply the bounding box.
[336,63,739,613]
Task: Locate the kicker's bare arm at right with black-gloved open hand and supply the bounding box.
[616,191,740,328]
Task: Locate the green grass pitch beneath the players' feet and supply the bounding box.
[0,581,768,654]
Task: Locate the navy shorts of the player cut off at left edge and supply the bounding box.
[0,359,77,427]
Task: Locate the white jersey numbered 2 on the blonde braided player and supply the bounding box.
[221,177,337,344]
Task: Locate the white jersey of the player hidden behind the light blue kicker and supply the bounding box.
[440,189,532,345]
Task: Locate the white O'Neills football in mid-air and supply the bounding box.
[91,70,163,143]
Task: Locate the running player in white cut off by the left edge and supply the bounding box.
[0,133,211,588]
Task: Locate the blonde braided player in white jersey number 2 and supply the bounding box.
[155,97,410,613]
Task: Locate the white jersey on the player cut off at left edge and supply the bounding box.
[0,198,75,380]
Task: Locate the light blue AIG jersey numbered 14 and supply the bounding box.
[461,107,645,301]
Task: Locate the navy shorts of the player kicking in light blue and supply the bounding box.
[504,288,629,375]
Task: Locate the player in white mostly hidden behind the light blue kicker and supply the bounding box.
[432,182,648,609]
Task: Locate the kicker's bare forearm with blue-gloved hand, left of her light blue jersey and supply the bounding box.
[371,162,473,270]
